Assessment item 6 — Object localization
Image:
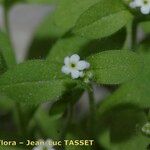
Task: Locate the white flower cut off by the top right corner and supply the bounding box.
[130,0,150,15]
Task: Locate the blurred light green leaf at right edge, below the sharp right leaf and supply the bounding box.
[99,56,150,113]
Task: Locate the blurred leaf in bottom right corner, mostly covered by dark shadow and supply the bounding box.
[99,105,149,150]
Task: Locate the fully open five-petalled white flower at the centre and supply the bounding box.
[61,54,90,79]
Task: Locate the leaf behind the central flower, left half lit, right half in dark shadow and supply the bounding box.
[47,30,126,63]
